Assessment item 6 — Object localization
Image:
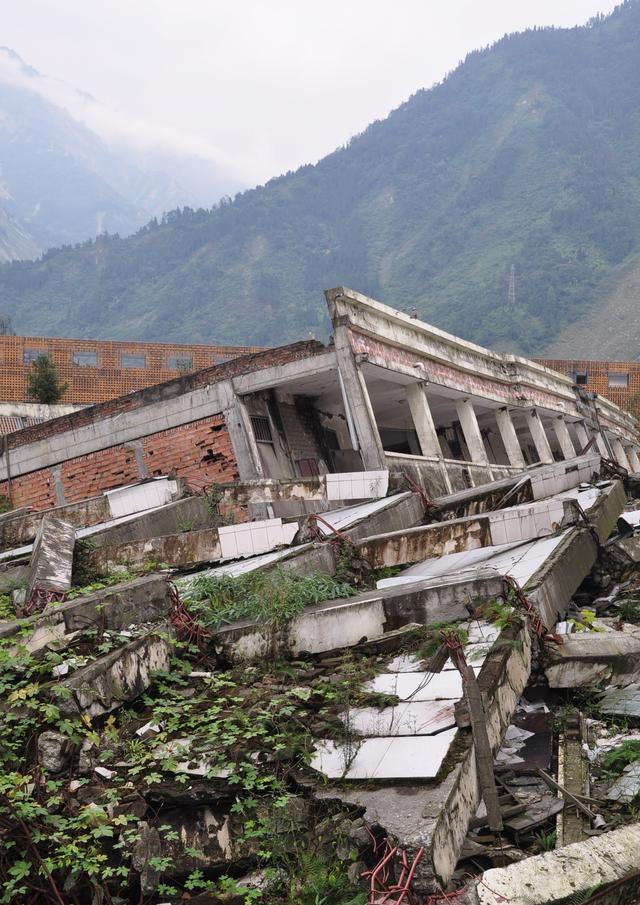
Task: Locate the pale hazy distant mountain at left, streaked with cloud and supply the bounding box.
[0,48,242,261]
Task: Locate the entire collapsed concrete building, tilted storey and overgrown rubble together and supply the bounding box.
[0,288,640,905]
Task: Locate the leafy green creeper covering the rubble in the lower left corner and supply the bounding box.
[0,620,372,905]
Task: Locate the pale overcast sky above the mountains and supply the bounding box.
[0,0,616,185]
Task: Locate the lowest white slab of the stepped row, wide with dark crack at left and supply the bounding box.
[311,729,457,780]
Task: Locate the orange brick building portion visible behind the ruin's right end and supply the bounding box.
[534,358,640,418]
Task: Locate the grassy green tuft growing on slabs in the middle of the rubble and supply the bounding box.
[182,569,357,629]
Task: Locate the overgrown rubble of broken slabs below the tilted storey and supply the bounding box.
[0,455,640,905]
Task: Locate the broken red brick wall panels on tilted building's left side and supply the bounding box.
[0,415,238,509]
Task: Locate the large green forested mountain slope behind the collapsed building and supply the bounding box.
[0,0,640,355]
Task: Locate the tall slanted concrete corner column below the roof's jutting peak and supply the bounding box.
[333,324,386,471]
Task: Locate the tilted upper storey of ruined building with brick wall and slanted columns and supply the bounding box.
[0,288,640,514]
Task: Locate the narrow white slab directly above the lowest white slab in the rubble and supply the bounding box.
[340,701,456,738]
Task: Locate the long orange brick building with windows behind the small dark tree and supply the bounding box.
[0,336,259,405]
